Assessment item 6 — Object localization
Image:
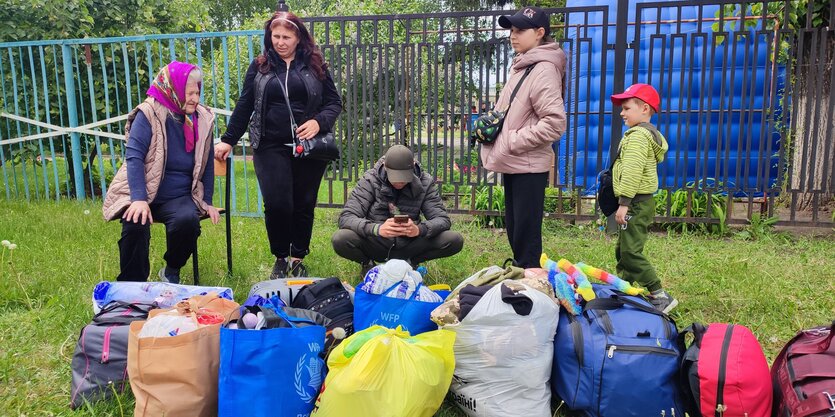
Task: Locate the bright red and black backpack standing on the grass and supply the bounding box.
[679,323,772,417]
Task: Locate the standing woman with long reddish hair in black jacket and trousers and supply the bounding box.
[215,12,342,279]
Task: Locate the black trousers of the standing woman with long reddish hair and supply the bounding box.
[253,142,328,258]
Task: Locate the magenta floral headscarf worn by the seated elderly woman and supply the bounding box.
[148,61,201,152]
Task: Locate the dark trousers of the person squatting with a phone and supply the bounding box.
[331,229,464,266]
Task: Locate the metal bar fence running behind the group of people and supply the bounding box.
[0,0,835,227]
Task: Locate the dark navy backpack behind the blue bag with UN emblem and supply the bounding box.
[290,277,354,352]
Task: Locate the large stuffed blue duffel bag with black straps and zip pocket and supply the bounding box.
[551,285,684,417]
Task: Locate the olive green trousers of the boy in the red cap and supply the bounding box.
[615,194,661,291]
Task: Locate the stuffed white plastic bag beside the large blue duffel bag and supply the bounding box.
[443,281,559,417]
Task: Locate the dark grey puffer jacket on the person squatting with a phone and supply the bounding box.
[339,156,452,237]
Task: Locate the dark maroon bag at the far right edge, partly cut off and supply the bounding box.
[771,321,835,417]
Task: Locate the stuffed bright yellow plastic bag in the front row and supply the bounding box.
[311,326,455,417]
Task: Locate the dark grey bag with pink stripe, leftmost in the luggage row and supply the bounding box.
[70,301,157,409]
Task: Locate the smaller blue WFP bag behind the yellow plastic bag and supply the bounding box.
[354,282,443,336]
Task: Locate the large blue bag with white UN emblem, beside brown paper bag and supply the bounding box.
[218,308,325,417]
